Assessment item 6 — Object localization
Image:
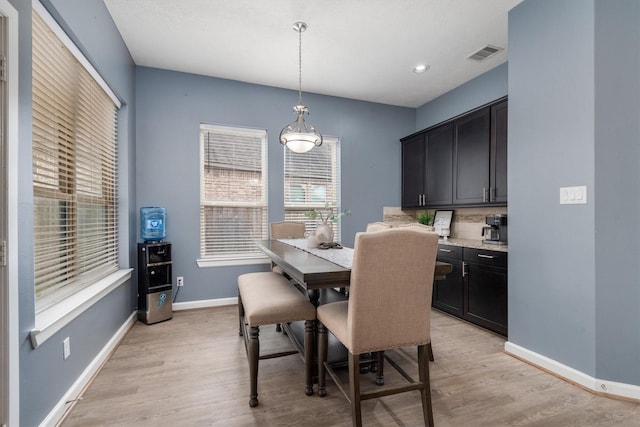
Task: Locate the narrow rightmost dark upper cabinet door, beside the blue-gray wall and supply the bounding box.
[490,101,507,203]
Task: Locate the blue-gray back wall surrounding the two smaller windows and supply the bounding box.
[136,67,415,302]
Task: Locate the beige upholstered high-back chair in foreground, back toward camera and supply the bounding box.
[316,227,438,426]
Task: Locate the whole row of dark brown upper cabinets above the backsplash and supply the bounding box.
[400,100,507,209]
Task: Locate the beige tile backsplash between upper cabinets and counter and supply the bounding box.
[382,206,507,240]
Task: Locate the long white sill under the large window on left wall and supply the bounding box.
[29,268,133,349]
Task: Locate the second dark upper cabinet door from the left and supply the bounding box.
[425,124,453,206]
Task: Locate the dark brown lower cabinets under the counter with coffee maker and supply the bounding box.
[432,245,508,336]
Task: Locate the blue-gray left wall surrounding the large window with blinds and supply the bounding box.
[10,0,135,426]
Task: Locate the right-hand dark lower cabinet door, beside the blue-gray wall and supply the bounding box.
[463,263,507,336]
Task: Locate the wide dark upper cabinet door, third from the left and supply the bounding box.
[453,108,491,204]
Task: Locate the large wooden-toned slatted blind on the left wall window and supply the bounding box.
[32,6,118,311]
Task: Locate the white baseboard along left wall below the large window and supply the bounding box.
[40,311,137,427]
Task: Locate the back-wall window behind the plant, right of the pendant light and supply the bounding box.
[284,137,340,240]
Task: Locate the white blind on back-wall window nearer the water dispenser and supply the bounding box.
[200,125,268,259]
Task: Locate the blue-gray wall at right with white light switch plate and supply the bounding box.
[508,0,640,385]
